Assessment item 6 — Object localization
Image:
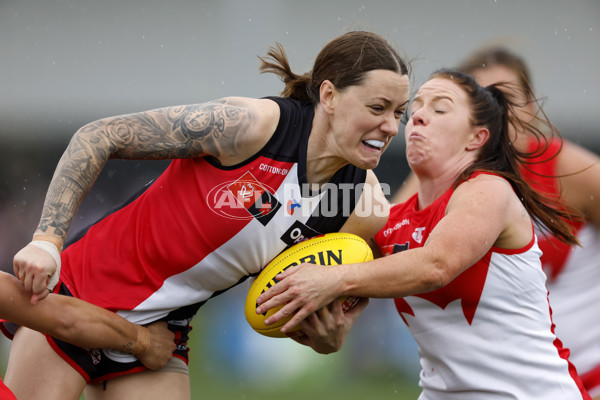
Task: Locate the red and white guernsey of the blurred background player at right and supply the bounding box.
[522,139,600,396]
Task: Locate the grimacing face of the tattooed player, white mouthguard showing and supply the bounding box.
[329,70,410,169]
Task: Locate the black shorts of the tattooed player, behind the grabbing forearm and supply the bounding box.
[46,282,199,383]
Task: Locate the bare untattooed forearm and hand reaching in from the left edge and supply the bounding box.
[0,272,175,369]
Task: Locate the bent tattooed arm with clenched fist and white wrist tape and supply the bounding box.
[13,97,279,303]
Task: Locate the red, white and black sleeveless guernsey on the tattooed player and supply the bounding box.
[61,98,366,324]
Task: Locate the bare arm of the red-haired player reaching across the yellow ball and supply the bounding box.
[256,175,533,332]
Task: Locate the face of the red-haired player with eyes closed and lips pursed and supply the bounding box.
[405,78,482,176]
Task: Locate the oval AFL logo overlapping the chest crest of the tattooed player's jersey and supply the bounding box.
[206,172,281,225]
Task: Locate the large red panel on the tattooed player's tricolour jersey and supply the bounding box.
[62,157,292,310]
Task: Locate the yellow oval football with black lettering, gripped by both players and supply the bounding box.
[245,233,373,338]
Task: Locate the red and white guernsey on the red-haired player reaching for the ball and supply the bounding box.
[375,173,589,400]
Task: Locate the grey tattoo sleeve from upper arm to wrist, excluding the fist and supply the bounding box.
[36,99,253,240]
